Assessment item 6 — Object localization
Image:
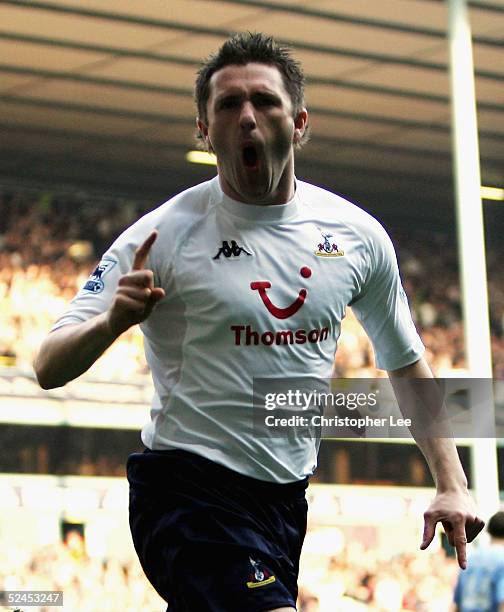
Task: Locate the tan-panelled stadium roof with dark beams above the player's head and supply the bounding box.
[0,0,504,220]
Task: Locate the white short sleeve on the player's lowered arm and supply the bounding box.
[350,222,425,370]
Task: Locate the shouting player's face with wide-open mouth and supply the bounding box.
[198,63,307,204]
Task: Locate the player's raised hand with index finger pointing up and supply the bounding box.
[107,231,165,337]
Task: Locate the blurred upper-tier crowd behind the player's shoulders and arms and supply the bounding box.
[0,186,504,380]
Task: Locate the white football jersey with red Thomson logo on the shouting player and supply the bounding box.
[54,177,424,482]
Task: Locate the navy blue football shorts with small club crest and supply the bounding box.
[127,450,308,612]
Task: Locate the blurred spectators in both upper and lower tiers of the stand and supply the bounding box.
[0,190,504,612]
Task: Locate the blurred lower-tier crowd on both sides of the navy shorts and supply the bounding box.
[0,532,457,612]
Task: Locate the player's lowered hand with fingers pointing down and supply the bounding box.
[420,489,485,569]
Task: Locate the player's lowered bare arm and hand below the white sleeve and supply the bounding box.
[388,357,485,569]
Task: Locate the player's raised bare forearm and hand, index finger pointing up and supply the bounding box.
[34,231,165,389]
